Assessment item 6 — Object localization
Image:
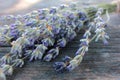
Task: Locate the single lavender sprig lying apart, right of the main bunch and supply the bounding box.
[53,8,109,72]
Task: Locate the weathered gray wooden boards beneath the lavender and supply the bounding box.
[0,13,120,80]
